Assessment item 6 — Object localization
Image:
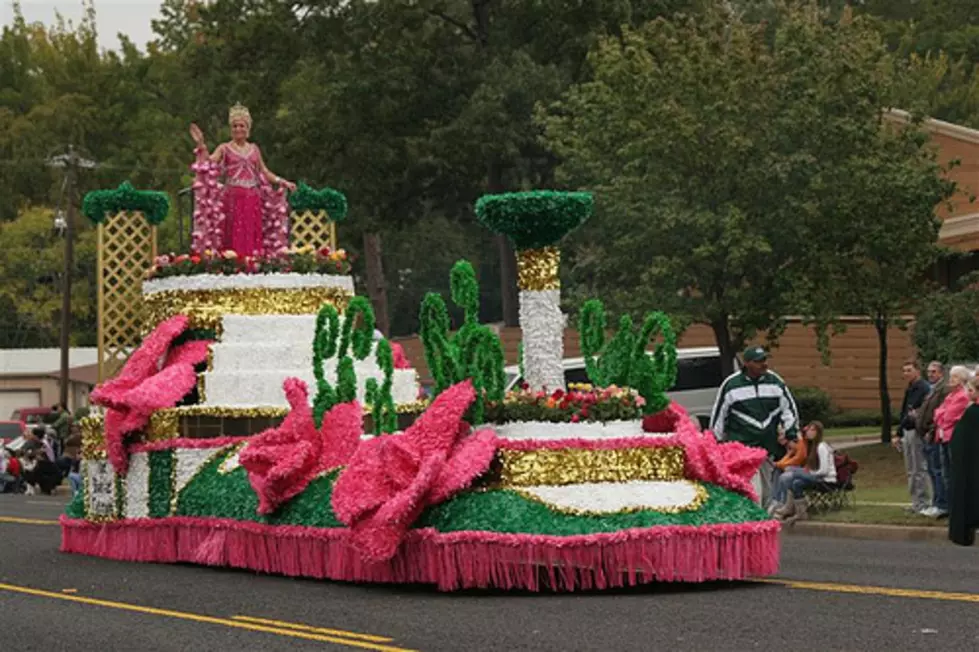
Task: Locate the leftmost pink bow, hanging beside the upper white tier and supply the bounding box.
[89,315,211,474]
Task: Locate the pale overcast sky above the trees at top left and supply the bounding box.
[0,0,161,50]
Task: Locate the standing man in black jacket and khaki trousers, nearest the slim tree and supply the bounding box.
[892,360,931,514]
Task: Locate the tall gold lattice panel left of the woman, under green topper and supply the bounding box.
[98,211,156,381]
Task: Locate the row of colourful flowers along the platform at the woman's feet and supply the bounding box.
[146,245,354,279]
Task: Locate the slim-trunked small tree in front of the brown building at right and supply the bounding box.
[810,112,955,442]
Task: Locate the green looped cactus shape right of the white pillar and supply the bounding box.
[578,299,677,414]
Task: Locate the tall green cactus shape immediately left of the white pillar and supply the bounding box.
[419,260,506,424]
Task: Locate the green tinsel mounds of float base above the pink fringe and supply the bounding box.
[109,448,768,536]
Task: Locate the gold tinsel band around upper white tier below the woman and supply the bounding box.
[143,287,351,329]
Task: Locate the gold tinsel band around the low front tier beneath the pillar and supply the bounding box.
[498,446,685,487]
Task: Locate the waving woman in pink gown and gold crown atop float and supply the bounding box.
[190,104,296,256]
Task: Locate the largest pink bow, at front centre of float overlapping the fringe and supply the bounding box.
[332,380,497,561]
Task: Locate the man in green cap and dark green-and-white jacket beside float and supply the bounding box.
[710,346,799,506]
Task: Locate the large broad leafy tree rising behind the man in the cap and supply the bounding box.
[540,6,904,371]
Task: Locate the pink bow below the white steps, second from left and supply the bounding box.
[238,378,364,514]
